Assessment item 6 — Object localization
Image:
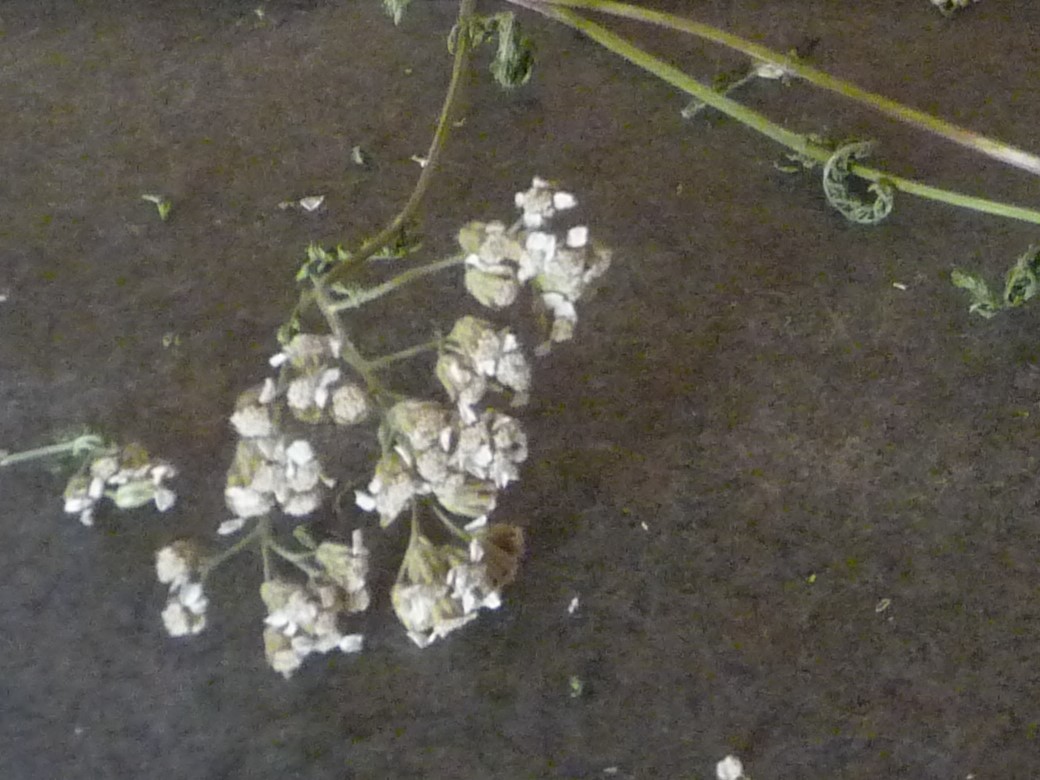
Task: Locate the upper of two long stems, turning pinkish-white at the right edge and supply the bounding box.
[524,0,1040,176]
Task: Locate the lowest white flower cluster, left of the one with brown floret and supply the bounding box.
[260,530,369,679]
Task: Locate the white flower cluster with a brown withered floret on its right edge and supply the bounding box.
[391,524,523,648]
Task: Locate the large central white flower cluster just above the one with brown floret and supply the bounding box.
[356,399,527,526]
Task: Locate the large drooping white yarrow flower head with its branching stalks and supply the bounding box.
[165,173,610,677]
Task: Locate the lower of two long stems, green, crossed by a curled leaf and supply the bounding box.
[510,0,1040,225]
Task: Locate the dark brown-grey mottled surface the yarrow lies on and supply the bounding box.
[0,0,1040,780]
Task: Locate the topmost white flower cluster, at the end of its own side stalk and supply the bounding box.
[459,178,610,342]
